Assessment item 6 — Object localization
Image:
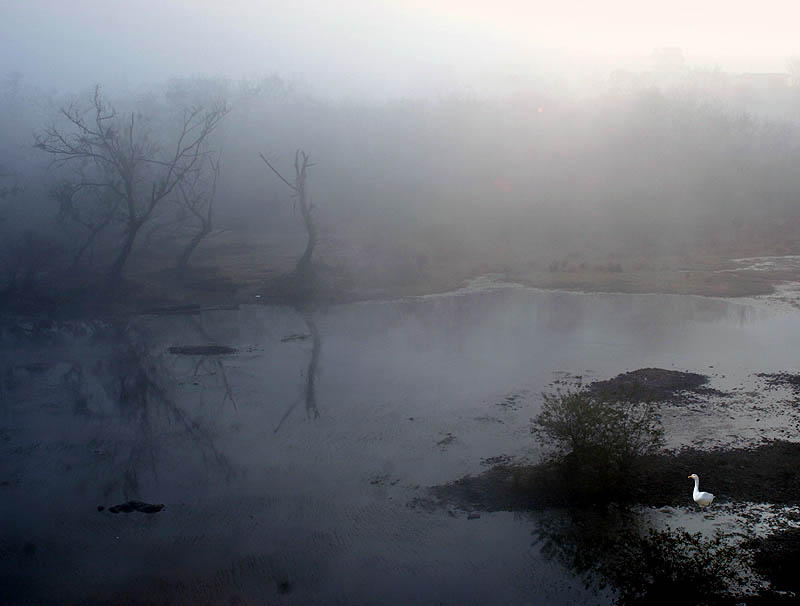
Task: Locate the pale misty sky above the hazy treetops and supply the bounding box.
[0,0,800,96]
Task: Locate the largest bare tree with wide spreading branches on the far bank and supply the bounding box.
[36,87,229,285]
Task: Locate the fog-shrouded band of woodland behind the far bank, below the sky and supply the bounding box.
[0,74,800,288]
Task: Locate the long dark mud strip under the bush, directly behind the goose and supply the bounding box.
[430,441,800,511]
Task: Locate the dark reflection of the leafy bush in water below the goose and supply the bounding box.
[534,506,754,606]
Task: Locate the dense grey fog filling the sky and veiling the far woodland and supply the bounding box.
[0,2,800,300]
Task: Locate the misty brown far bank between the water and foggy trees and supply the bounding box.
[6,242,800,317]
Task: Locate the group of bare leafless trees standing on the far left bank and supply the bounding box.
[0,77,318,302]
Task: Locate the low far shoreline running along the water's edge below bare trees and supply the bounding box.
[7,256,800,324]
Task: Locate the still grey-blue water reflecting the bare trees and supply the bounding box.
[0,282,800,604]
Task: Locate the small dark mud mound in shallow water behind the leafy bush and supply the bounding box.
[586,368,725,404]
